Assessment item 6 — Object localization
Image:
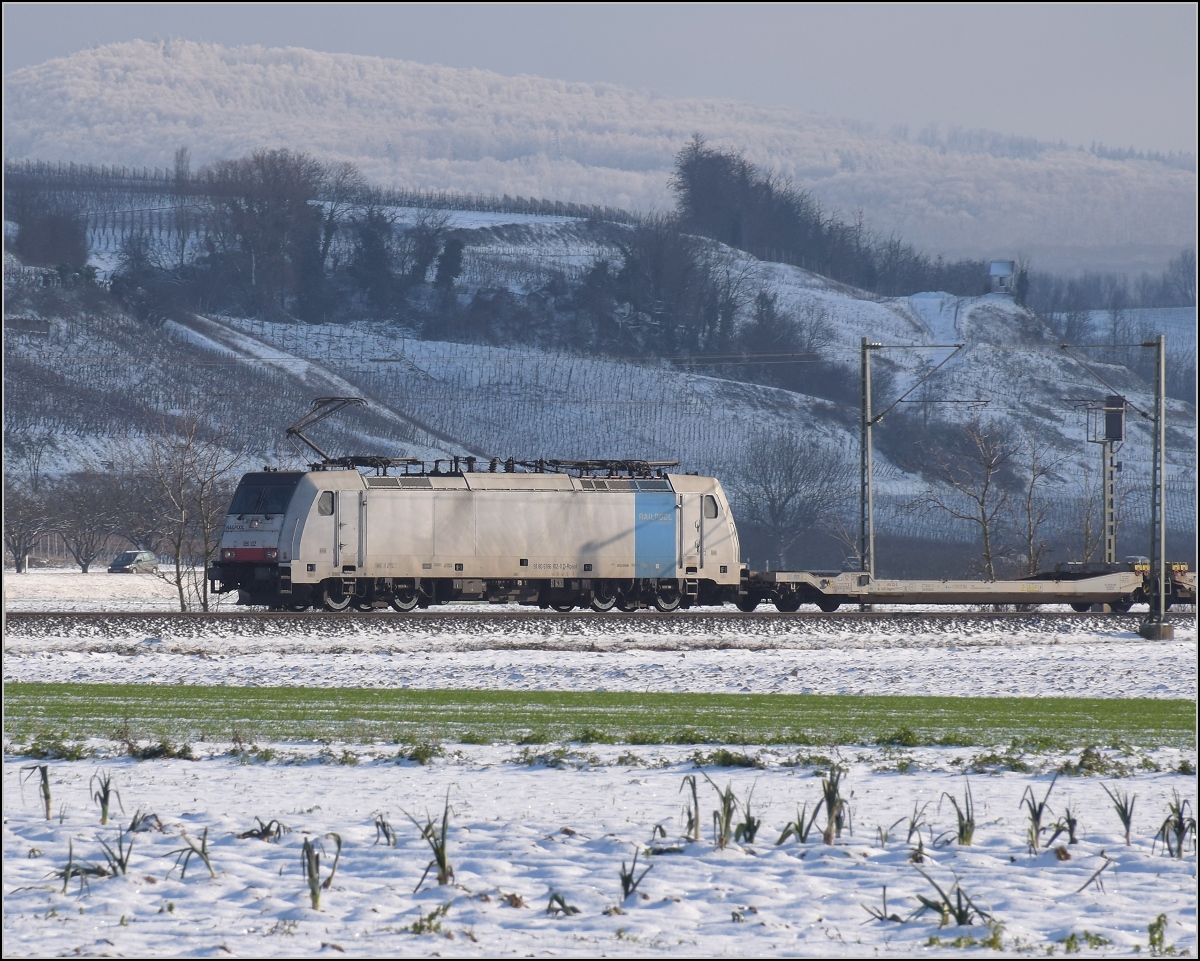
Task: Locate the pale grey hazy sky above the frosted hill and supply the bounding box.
[4,2,1196,152]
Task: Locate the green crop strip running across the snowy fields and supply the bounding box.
[4,684,1196,749]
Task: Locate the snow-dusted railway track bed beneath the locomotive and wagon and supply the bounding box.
[5,608,1195,641]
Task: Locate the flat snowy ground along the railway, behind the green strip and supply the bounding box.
[4,571,1196,698]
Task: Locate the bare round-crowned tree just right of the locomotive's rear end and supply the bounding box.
[730,428,856,569]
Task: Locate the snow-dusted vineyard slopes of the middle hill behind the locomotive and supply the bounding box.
[5,211,1195,564]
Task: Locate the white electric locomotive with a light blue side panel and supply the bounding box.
[209,470,742,611]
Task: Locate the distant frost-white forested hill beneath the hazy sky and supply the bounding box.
[4,41,1196,272]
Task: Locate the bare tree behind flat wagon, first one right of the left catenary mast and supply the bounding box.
[913,418,1021,581]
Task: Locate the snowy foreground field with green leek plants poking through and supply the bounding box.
[4,747,1196,957]
